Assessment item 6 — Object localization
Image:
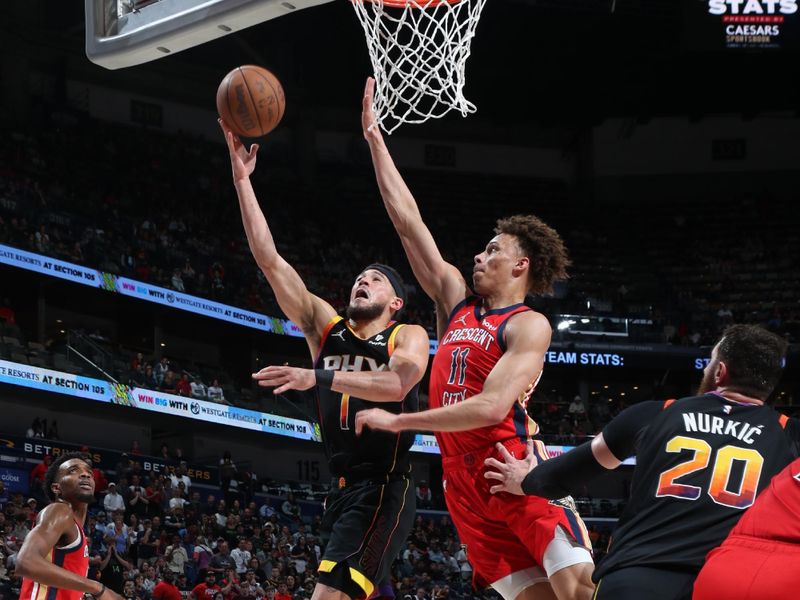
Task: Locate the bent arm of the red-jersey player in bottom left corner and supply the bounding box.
[16,503,122,600]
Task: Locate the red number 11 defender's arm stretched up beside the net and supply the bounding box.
[361,77,470,314]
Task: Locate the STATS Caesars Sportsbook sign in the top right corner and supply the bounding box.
[707,0,797,48]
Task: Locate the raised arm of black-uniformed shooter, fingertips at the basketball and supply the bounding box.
[219,119,336,353]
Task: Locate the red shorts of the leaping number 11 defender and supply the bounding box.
[442,440,592,588]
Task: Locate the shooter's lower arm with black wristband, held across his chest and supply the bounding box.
[253,325,429,402]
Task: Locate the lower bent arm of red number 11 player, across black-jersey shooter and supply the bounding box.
[356,312,551,433]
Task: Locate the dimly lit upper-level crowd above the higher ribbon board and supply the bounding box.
[0,115,800,354]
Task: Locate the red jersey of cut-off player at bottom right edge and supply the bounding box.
[731,458,800,544]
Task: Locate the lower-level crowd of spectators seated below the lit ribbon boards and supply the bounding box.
[0,445,624,600]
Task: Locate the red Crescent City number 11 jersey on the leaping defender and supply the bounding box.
[429,296,541,456]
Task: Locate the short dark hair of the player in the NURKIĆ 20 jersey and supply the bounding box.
[717,325,789,400]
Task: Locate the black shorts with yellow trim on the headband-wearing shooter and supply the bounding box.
[318,476,416,598]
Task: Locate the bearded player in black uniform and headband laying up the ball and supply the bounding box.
[220,120,429,600]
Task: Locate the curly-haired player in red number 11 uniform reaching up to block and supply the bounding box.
[356,78,594,600]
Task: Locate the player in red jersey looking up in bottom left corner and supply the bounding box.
[16,452,122,600]
